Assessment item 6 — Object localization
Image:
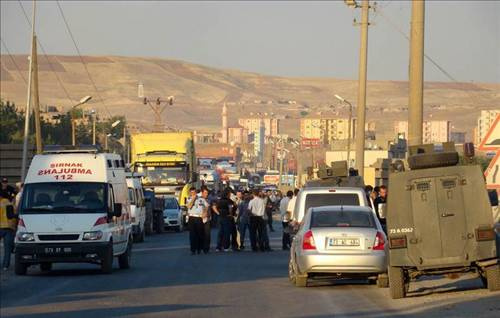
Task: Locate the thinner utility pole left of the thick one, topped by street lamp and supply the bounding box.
[349,0,370,176]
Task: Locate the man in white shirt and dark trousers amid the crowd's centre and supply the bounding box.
[248,190,266,252]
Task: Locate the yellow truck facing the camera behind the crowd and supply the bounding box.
[130,132,198,211]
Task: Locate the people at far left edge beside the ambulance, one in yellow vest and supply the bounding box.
[0,178,22,271]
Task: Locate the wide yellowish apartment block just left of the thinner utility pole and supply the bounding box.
[300,118,356,144]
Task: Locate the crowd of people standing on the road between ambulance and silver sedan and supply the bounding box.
[187,186,293,255]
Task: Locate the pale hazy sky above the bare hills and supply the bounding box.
[0,1,500,83]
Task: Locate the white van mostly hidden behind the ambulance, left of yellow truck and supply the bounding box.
[125,172,146,242]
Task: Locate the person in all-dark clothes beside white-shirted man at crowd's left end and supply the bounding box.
[214,189,236,252]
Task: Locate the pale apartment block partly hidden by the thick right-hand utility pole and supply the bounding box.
[394,120,451,144]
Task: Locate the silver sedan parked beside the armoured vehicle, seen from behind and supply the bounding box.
[288,206,388,287]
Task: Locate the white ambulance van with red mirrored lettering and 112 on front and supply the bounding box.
[15,148,132,275]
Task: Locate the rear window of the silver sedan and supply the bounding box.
[311,210,376,228]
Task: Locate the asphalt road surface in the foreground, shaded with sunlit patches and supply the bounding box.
[0,224,500,318]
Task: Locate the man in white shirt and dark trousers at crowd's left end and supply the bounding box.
[187,187,208,255]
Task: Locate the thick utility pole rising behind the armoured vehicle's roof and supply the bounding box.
[408,0,425,146]
